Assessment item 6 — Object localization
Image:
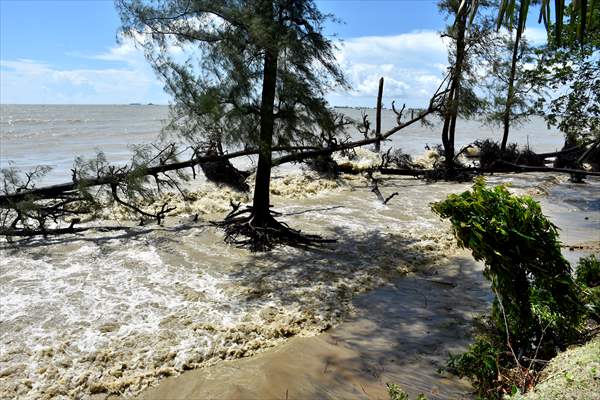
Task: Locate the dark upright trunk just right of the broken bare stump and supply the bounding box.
[442,10,468,170]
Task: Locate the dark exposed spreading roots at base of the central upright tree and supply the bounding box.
[213,203,335,252]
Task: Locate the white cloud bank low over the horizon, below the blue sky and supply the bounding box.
[0,28,546,107]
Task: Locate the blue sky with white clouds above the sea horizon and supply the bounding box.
[0,0,545,107]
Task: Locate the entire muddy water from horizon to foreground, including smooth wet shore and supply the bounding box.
[0,106,600,399]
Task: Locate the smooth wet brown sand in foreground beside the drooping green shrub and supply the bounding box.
[140,253,491,400]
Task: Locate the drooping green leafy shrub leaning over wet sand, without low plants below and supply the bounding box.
[433,178,583,353]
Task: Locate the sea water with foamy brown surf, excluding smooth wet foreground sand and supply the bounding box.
[0,106,600,399]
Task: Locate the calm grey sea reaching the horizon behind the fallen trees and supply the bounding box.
[0,105,563,184]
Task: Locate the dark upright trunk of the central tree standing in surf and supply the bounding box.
[252,48,278,221]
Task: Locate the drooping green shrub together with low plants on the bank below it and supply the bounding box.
[432,178,600,399]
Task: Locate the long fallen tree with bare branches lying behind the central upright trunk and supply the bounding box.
[0,70,448,242]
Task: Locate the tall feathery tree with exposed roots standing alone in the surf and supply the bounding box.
[117,0,347,251]
